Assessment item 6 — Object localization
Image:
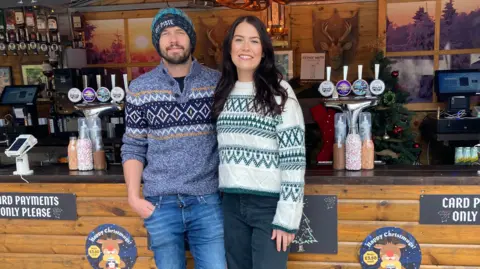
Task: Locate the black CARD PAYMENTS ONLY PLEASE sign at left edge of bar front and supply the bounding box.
[0,192,77,220]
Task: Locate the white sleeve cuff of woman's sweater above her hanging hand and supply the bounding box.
[272,197,303,233]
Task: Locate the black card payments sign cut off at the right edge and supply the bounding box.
[420,195,480,225]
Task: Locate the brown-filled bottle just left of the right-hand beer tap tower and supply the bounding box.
[333,113,347,170]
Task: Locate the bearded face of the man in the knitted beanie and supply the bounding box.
[158,26,192,64]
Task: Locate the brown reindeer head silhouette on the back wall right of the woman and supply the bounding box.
[320,21,352,69]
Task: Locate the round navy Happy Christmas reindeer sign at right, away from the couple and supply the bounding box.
[360,227,422,269]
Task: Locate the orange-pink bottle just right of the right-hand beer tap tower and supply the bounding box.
[360,112,375,169]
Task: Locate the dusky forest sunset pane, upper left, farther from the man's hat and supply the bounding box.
[85,19,126,64]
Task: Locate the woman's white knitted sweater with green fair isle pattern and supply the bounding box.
[217,81,306,233]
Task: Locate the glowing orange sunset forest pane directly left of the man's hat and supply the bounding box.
[128,18,160,63]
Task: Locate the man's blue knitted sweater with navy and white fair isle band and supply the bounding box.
[121,60,220,197]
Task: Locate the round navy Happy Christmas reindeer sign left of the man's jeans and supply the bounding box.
[85,224,137,269]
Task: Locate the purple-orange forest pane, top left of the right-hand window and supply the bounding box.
[387,1,435,52]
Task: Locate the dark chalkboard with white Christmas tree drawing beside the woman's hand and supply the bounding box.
[290,195,338,254]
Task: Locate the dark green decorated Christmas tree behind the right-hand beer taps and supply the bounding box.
[370,51,420,164]
